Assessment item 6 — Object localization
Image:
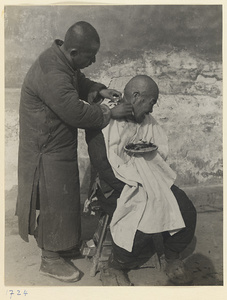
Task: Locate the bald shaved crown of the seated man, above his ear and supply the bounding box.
[124,75,159,100]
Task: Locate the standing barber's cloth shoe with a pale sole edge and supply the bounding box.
[40,257,80,282]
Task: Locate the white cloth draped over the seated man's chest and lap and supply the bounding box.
[103,114,185,251]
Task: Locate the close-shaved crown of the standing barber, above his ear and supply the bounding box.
[64,21,100,51]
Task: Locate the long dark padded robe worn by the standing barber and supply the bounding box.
[16,40,105,251]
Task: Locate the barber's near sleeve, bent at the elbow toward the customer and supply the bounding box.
[40,71,110,129]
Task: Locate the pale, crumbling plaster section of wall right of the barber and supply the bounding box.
[81,50,223,190]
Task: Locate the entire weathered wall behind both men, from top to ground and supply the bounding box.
[5,6,223,191]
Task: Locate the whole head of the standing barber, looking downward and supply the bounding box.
[63,21,100,69]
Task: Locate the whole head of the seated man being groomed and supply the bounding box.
[124,75,159,123]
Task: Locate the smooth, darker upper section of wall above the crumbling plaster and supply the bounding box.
[4,5,222,88]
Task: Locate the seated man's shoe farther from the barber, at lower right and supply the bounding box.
[165,259,193,285]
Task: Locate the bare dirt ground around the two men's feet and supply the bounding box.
[5,186,223,288]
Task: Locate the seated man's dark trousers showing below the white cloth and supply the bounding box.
[111,185,196,269]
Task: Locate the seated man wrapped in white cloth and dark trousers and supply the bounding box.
[86,75,196,284]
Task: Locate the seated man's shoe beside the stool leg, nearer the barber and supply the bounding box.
[100,267,133,286]
